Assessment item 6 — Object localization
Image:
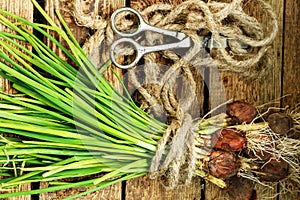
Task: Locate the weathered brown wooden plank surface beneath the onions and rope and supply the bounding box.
[0,0,300,200]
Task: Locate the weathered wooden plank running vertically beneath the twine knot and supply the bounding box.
[125,0,204,200]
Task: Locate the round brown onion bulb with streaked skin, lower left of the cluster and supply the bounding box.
[206,151,240,179]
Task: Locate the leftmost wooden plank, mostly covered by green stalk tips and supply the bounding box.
[0,0,33,200]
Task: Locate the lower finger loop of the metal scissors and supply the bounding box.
[110,38,145,69]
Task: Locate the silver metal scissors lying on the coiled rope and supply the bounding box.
[110,7,246,69]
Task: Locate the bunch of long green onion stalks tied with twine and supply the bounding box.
[0,0,298,199]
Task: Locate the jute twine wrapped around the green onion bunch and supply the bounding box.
[149,114,196,189]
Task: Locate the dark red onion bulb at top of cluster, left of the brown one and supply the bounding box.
[227,101,257,123]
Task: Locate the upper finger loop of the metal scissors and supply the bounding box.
[110,7,148,37]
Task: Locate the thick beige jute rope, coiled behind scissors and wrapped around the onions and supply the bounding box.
[66,0,278,188]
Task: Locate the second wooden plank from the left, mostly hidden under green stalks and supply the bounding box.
[40,0,125,200]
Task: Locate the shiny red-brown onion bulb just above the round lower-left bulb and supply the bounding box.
[213,128,246,151]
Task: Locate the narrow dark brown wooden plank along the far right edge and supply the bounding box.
[279,0,300,200]
